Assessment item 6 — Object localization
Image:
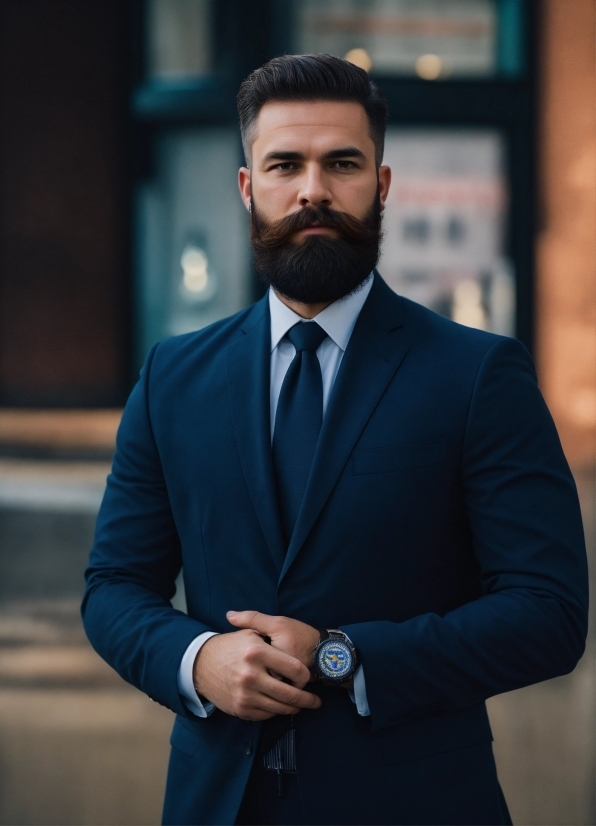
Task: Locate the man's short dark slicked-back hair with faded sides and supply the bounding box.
[237,54,388,166]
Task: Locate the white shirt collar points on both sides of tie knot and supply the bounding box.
[269,273,373,352]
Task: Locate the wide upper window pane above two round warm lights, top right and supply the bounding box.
[297,0,522,80]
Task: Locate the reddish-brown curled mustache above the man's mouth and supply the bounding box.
[251,205,377,249]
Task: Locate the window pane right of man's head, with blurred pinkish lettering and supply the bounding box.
[379,128,515,335]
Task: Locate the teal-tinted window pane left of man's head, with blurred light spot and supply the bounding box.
[137,127,251,360]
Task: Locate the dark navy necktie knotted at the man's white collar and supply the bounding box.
[273,321,327,543]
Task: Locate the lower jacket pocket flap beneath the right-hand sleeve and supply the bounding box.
[381,703,493,766]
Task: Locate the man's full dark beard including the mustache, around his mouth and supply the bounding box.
[251,189,382,304]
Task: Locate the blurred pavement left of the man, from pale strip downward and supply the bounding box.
[0,459,173,826]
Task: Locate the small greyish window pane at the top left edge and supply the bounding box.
[147,0,213,80]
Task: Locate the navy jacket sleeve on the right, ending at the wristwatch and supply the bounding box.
[342,339,587,729]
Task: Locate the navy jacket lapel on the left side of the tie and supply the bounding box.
[228,296,285,570]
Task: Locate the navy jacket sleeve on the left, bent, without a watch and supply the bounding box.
[82,345,211,716]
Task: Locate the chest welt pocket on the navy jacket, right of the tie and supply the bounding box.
[352,436,449,476]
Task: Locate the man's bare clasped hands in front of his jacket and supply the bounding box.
[193,611,321,720]
